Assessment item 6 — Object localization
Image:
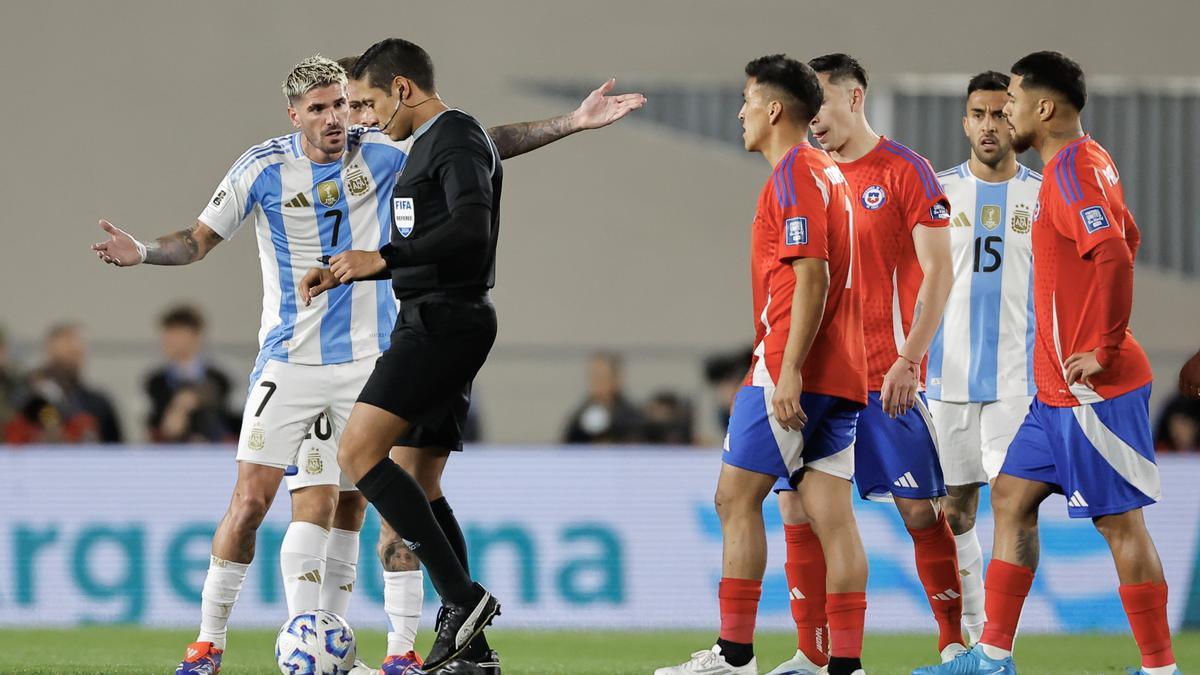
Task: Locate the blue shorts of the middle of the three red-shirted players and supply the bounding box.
[854,392,946,501]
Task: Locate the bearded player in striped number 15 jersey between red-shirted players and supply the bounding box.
[926,71,1042,643]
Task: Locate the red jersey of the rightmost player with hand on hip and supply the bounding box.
[1033,136,1153,407]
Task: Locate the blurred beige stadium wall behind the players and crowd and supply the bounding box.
[0,0,1200,442]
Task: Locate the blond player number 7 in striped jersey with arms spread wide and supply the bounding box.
[92,56,641,675]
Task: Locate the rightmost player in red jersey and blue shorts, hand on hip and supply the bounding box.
[913,52,1178,675]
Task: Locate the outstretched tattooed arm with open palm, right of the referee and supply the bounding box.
[487,79,646,160]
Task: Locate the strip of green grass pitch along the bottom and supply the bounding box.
[0,626,1200,675]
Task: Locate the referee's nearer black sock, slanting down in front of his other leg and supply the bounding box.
[356,458,478,605]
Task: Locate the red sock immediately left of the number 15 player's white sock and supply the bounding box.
[908,513,964,651]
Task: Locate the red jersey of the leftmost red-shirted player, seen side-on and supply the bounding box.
[746,143,866,404]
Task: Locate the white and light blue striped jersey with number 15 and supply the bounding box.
[928,162,1042,402]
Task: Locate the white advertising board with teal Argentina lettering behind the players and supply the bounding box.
[0,447,1200,633]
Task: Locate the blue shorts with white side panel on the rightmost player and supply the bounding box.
[1001,384,1162,518]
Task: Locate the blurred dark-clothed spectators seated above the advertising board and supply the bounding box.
[0,305,1200,453]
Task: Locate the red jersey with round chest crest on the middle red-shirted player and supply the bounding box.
[838,137,950,392]
